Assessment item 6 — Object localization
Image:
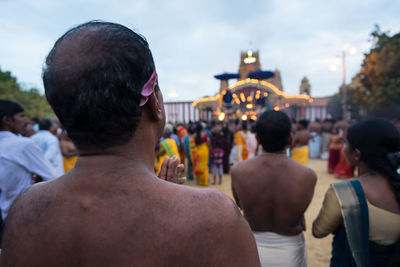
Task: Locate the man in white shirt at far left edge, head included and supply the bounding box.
[0,99,56,236]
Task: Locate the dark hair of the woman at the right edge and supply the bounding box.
[347,119,400,203]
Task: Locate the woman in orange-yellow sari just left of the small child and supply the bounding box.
[190,123,210,186]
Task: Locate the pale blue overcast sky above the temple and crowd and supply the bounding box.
[0,0,400,101]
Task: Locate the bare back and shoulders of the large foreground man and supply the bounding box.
[1,159,259,266]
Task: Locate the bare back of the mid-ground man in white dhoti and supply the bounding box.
[232,148,317,236]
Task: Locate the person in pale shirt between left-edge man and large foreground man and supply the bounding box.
[30,119,64,176]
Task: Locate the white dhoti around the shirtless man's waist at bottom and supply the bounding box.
[253,232,307,267]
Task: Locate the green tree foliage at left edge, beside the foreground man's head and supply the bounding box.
[0,69,54,118]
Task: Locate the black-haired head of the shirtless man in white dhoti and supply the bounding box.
[256,111,292,152]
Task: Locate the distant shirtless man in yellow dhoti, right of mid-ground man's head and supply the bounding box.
[290,120,312,166]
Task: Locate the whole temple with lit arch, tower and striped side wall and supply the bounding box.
[165,51,330,123]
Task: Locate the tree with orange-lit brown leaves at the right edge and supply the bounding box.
[349,26,400,118]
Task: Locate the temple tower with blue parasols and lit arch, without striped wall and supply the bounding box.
[193,51,313,120]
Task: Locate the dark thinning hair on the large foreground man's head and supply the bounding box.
[43,21,155,149]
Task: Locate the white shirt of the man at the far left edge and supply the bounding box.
[0,131,56,220]
